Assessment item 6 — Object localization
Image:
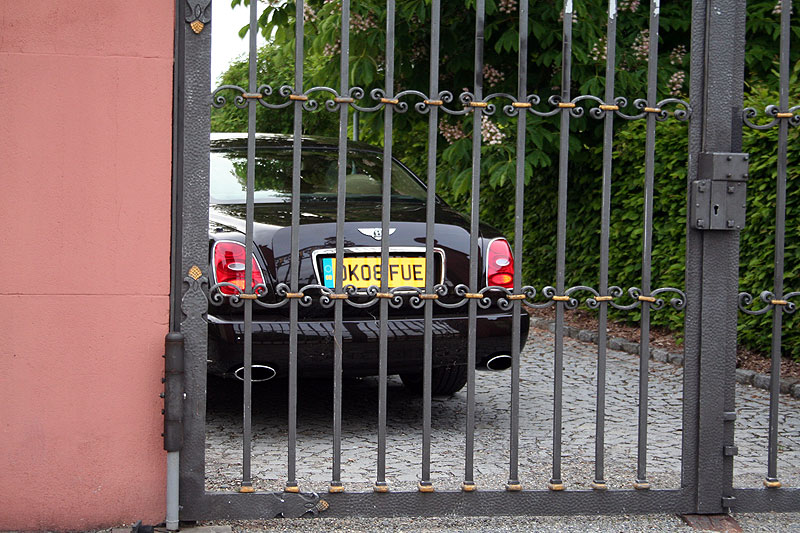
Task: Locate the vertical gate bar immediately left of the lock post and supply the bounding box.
[633,0,660,490]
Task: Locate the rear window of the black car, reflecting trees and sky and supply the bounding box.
[210,150,426,204]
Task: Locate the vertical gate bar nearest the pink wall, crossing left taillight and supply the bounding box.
[240,2,258,492]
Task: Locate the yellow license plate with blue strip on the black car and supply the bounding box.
[322,257,425,289]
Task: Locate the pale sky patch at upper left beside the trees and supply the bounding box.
[211,0,255,89]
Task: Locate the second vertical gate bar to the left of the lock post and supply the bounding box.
[591,0,617,490]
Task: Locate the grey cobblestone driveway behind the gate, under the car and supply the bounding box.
[206,329,800,492]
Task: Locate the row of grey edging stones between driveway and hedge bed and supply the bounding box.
[531,317,800,398]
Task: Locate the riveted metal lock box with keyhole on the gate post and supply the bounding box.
[689,152,750,230]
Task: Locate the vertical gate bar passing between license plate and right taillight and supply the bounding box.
[462,0,485,490]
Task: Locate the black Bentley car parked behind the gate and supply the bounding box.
[208,134,528,394]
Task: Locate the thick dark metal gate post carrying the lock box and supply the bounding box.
[682,0,745,514]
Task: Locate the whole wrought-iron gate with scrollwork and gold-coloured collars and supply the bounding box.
[165,0,800,527]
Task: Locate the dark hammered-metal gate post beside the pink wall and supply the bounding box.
[170,0,212,525]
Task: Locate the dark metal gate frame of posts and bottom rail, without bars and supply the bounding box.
[168,0,800,525]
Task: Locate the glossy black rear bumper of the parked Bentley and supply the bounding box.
[208,311,529,377]
